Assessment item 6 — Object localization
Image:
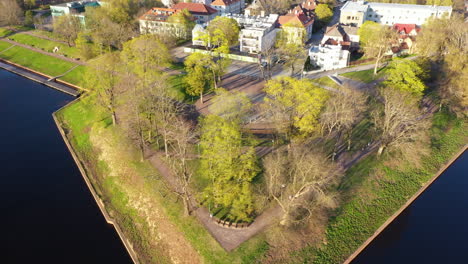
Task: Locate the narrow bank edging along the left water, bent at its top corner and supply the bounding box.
[52,98,140,264]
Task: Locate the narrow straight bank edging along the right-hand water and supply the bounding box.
[343,144,468,264]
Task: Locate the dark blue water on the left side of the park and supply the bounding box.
[0,70,131,264]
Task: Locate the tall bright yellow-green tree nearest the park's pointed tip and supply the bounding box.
[200,115,259,221]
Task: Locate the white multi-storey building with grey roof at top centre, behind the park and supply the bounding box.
[225,14,279,53]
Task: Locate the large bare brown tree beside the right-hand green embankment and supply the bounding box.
[372,88,429,155]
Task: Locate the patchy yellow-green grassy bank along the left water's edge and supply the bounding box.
[57,97,268,263]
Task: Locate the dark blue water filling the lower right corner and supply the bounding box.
[352,152,468,264]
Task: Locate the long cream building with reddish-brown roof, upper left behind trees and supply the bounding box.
[139,8,190,39]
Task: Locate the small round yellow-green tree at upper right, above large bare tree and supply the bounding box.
[384,58,427,96]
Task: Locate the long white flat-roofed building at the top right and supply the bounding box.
[340,1,452,27]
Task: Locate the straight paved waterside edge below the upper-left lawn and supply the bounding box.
[0,59,81,97]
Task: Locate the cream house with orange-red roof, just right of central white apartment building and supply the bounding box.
[279,1,315,44]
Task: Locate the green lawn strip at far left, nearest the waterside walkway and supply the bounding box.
[0,46,76,76]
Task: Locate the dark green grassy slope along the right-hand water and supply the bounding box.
[293,108,468,263]
